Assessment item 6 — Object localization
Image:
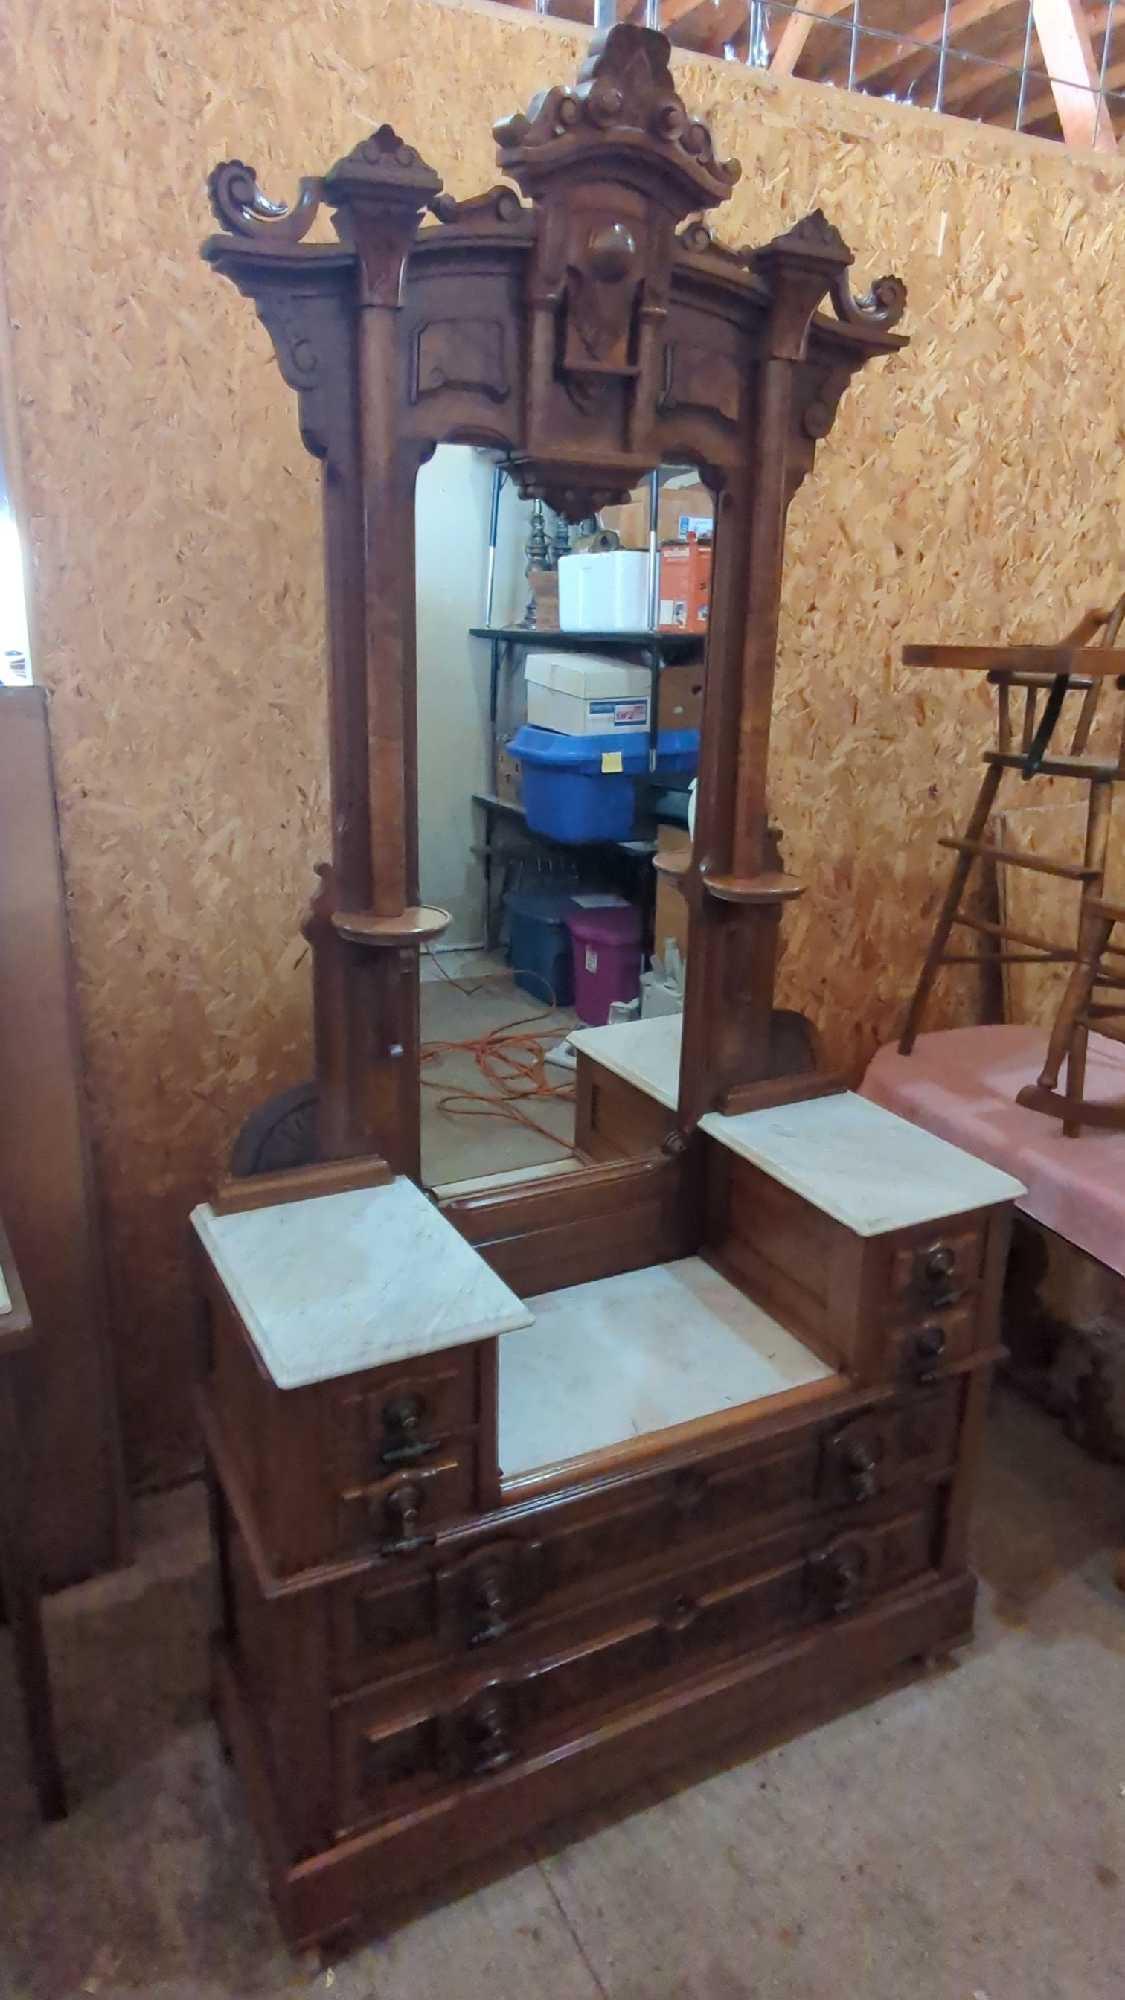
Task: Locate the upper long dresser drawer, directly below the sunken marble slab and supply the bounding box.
[332,1380,948,1688]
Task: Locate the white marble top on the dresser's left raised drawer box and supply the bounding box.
[192,1180,530,1388]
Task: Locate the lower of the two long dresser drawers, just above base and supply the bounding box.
[334,1488,945,1832]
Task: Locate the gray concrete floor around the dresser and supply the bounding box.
[0,1396,1125,2000]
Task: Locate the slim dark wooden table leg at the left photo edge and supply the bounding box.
[0,1360,66,1820]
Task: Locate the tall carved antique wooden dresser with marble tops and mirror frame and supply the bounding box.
[194,26,1021,1942]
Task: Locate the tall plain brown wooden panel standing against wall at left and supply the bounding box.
[0,688,128,1588]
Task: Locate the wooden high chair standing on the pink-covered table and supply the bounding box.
[899,596,1125,1056]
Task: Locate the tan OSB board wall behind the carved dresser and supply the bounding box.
[0,0,1123,1478]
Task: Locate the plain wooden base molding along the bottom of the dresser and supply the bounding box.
[212,1572,977,1950]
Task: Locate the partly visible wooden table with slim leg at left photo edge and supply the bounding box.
[0,1222,66,1820]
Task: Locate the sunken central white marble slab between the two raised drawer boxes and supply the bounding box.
[500,1256,833,1478]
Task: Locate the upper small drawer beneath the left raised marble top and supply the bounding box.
[334,1346,478,1488]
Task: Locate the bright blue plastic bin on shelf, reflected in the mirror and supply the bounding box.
[508,722,649,844]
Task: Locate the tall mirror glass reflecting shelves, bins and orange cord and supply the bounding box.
[416,446,713,1188]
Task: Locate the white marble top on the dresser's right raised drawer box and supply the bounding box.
[699,1090,1027,1236]
